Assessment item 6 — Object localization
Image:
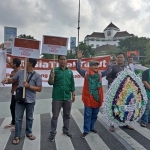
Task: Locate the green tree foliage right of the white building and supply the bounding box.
[118,36,149,55]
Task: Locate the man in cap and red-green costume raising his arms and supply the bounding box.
[76,51,111,138]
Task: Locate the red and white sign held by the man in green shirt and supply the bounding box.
[42,35,68,55]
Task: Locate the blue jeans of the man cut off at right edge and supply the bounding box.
[141,100,150,123]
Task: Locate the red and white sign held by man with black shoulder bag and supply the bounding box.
[12,38,40,58]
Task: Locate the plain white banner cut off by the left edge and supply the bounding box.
[0,50,6,87]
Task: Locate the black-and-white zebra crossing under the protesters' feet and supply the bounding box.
[0,109,150,150]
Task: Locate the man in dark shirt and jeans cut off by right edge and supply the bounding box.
[141,69,150,127]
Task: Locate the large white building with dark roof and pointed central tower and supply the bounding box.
[84,22,133,48]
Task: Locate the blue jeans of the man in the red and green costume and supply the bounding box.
[83,106,99,133]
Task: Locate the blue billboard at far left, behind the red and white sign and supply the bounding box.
[4,27,17,42]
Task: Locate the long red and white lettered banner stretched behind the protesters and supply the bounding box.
[6,54,110,87]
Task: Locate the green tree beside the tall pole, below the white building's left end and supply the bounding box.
[76,42,95,58]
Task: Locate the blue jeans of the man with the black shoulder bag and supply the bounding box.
[15,102,35,137]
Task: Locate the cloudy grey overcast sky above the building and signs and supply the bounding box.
[0,0,150,43]
